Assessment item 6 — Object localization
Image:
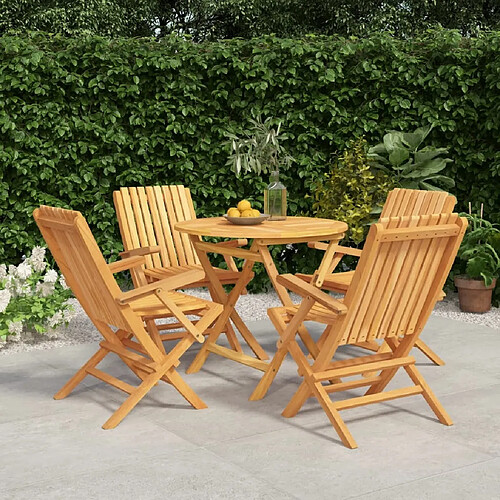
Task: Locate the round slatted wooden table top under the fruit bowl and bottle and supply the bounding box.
[175,217,348,240]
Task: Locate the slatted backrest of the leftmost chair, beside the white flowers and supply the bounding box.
[33,205,133,330]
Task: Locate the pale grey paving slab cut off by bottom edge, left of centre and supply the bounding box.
[3,449,296,500]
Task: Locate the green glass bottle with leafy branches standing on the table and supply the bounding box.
[227,117,293,220]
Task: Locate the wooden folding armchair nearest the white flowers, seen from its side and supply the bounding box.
[33,206,222,429]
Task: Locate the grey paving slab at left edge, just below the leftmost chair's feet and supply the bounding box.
[0,405,196,490]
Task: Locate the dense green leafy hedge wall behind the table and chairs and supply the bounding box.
[0,30,500,286]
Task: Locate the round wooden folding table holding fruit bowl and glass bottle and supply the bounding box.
[175,217,348,373]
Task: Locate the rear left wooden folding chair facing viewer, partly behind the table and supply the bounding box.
[113,185,253,352]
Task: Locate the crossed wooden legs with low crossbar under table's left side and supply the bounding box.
[186,236,269,373]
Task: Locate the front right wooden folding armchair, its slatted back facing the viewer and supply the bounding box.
[250,214,467,448]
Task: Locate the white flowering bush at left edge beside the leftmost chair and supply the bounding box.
[0,247,73,343]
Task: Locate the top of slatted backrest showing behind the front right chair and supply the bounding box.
[380,188,457,218]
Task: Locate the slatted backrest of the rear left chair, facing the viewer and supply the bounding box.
[113,185,200,269]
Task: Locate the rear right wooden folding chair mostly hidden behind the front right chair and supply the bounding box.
[296,188,457,366]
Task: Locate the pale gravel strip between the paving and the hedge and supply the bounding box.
[0,290,500,355]
